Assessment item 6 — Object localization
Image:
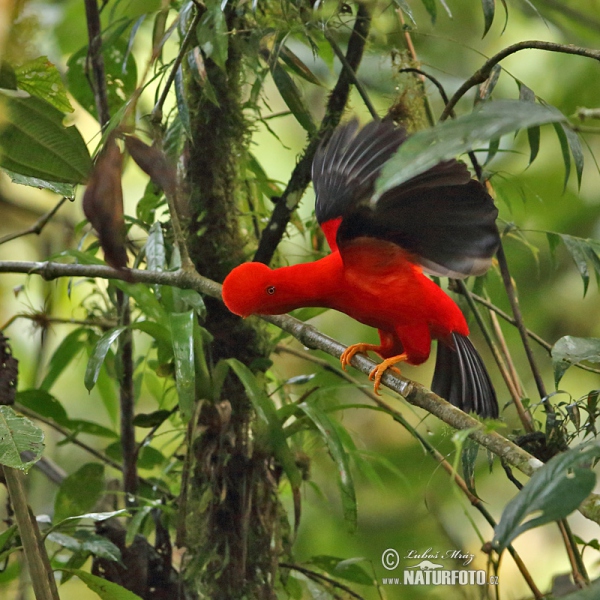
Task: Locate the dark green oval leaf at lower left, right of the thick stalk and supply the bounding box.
[52,463,105,525]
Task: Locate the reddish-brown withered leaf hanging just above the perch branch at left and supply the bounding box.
[83,134,127,269]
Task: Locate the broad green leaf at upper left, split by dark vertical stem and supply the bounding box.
[67,36,137,118]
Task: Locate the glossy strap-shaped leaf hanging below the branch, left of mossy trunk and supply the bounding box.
[170,310,196,423]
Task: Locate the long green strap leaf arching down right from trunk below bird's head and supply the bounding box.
[223,358,302,490]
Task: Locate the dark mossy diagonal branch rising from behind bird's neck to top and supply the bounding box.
[254,2,371,264]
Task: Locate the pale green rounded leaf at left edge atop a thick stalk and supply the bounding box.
[0,406,44,471]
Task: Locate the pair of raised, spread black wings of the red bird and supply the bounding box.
[313,121,500,277]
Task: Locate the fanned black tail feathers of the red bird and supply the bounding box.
[431,333,498,419]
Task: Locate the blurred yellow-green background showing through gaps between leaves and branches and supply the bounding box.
[0,0,600,600]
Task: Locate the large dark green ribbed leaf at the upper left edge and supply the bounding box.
[0,96,92,183]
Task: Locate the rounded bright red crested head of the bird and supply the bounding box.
[223,262,277,317]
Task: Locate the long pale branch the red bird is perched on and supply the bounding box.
[0,261,600,524]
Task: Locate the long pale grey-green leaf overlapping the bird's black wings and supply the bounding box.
[373,100,565,201]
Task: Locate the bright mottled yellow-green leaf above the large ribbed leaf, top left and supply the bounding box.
[15,56,73,113]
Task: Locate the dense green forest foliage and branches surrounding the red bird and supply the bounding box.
[0,0,600,600]
